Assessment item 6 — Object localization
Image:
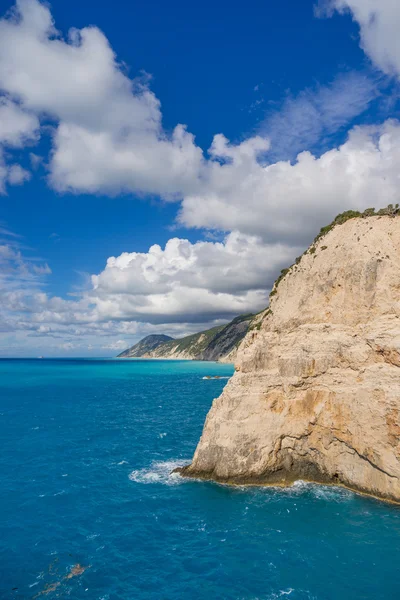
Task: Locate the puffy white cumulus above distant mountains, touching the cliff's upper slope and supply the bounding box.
[90,232,300,323]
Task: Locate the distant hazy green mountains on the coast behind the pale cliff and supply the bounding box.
[118,314,258,362]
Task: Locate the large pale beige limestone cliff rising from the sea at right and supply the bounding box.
[182,216,400,502]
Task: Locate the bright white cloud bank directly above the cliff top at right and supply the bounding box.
[179,121,400,244]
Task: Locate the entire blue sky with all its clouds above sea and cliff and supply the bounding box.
[0,0,400,357]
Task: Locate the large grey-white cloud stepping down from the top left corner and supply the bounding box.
[0,0,203,197]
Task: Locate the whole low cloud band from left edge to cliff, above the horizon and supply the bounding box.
[0,226,300,351]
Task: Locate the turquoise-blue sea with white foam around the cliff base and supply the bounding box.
[0,360,400,600]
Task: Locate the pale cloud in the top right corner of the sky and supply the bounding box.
[320,0,400,75]
